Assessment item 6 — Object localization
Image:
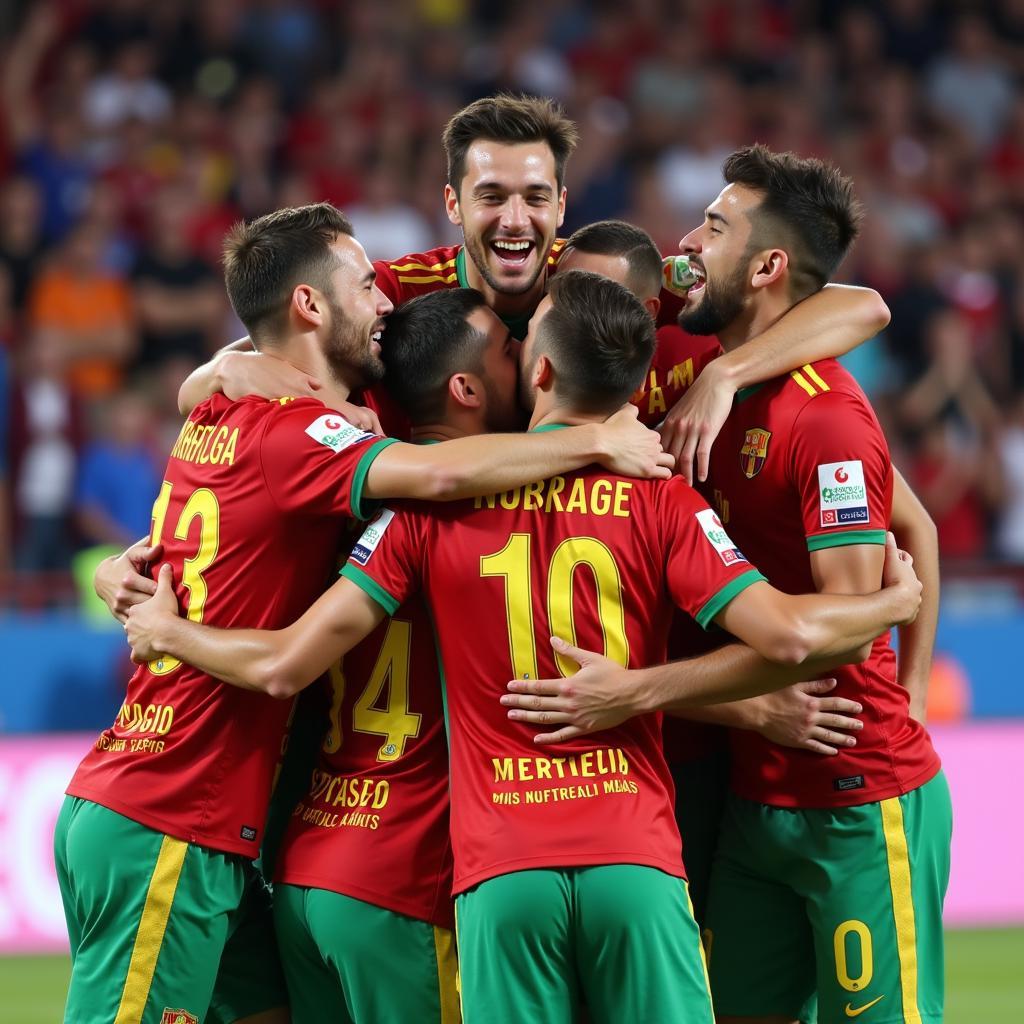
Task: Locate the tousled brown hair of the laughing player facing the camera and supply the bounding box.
[441,92,578,193]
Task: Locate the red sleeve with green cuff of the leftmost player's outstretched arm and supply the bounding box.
[260,398,396,519]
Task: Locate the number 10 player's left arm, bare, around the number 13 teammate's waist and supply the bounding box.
[125,564,386,698]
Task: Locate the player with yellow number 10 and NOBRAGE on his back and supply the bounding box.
[119,272,920,1022]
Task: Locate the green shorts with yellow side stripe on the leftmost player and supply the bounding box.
[53,797,287,1024]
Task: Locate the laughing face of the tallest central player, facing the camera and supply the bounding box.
[444,139,565,303]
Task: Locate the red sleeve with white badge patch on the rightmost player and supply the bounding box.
[787,390,893,551]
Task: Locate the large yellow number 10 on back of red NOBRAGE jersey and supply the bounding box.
[480,534,630,679]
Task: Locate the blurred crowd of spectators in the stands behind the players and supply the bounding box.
[0,0,1024,598]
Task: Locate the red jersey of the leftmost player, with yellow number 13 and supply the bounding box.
[68,394,394,858]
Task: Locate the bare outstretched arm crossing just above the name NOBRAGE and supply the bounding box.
[364,406,672,501]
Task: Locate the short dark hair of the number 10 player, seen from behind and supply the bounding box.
[532,270,654,414]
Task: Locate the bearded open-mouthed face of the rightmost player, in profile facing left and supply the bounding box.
[679,184,761,335]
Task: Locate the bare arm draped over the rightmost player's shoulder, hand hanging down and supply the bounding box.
[660,285,890,481]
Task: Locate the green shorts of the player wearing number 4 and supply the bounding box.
[273,884,461,1024]
